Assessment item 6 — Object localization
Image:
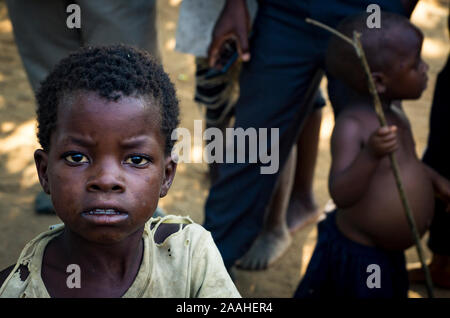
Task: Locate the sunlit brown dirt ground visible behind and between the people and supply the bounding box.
[0,0,450,297]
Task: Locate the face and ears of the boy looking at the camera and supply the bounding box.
[35,92,176,243]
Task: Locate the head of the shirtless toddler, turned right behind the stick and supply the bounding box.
[326,12,428,100]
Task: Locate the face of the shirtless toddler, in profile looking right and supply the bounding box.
[384,27,428,99]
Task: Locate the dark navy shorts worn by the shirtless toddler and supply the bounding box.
[294,211,409,298]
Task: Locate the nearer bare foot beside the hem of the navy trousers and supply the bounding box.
[236,230,292,270]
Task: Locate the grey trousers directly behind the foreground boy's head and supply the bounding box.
[6,0,159,91]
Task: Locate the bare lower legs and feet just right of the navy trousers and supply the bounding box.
[237,90,324,269]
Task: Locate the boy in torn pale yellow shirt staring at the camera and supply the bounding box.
[0,45,239,297]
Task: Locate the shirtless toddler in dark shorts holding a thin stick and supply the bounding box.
[295,12,450,298]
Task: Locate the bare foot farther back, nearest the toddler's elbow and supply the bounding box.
[286,196,323,233]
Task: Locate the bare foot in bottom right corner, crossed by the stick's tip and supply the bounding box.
[408,254,450,289]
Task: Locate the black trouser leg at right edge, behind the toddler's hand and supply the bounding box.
[423,57,450,255]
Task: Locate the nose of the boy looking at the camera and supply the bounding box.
[86,165,125,193]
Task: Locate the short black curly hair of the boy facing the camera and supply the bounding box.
[36,45,179,154]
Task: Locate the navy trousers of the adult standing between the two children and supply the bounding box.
[204,0,404,268]
